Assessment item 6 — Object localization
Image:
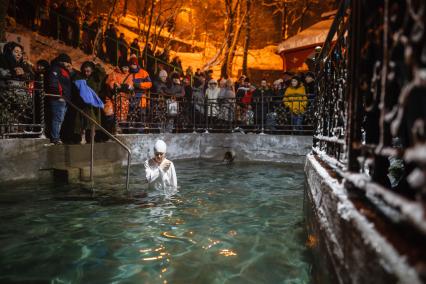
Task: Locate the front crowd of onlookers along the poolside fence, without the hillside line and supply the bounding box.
[0,39,315,143]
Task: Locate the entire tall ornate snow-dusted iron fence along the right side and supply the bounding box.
[313,0,426,268]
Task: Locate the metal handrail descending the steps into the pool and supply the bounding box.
[44,93,132,192]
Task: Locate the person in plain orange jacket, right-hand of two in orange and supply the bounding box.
[129,55,152,131]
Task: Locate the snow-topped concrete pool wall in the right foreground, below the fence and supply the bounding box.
[305,154,421,283]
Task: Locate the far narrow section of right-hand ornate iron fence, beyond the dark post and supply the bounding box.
[313,1,350,168]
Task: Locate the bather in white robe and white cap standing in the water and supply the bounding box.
[145,140,178,196]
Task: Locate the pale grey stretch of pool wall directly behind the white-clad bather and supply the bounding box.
[119,133,312,164]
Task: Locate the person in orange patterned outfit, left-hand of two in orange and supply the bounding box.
[104,60,133,132]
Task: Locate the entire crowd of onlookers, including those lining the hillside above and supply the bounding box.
[0,1,316,144]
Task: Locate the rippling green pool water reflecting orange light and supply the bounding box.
[0,160,311,283]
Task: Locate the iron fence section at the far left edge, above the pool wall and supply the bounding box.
[0,78,44,138]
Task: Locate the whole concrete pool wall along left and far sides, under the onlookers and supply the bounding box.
[0,133,312,183]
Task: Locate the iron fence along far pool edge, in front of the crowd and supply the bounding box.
[110,93,314,135]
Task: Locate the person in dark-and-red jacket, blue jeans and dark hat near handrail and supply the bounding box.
[46,53,72,144]
